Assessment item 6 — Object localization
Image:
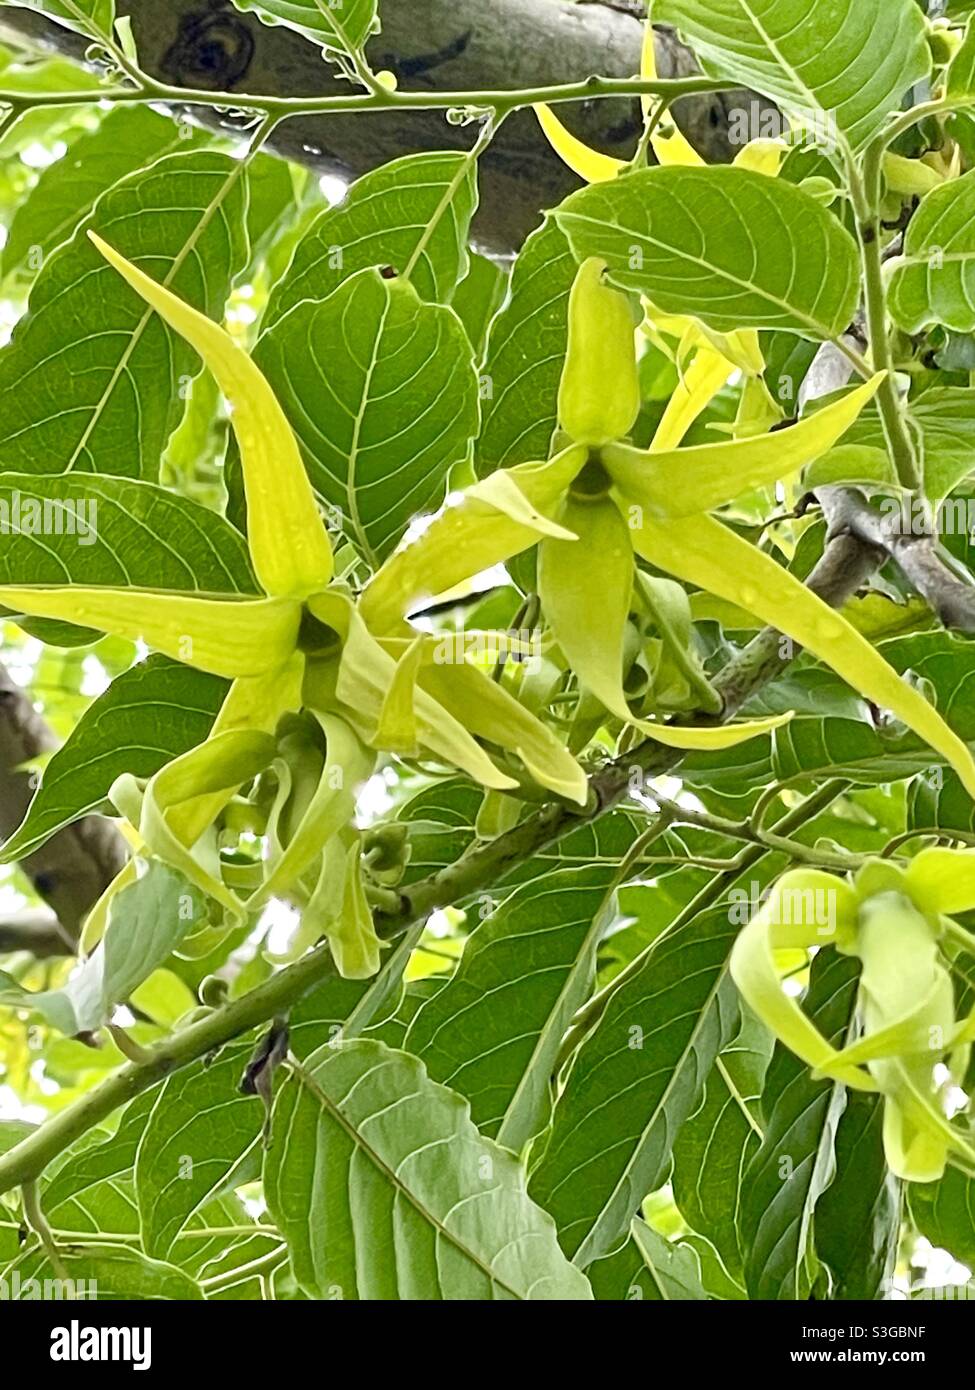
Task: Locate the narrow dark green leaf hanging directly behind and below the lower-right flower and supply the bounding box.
[741,951,860,1300]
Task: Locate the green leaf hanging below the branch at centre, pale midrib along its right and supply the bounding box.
[405,865,613,1154]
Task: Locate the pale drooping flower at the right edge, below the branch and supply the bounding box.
[732,848,975,1183]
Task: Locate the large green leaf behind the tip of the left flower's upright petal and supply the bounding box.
[0,152,246,478]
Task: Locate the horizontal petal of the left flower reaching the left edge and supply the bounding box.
[0,585,300,677]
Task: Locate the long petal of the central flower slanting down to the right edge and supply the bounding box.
[630,516,975,796]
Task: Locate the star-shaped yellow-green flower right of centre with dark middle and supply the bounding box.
[360,260,975,795]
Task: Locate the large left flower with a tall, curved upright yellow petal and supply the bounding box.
[0,234,587,972]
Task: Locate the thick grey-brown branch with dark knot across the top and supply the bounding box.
[0,0,765,253]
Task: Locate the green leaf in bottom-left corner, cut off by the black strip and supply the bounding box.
[4,1241,203,1302]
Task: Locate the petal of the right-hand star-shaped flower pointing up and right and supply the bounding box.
[602,373,886,517]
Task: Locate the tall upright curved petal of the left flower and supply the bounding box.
[88,232,332,598]
